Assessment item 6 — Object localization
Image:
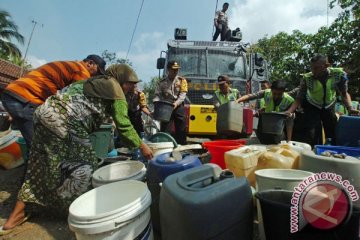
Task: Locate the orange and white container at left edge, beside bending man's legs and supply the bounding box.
[0,131,24,169]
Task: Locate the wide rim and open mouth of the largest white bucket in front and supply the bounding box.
[68,180,151,234]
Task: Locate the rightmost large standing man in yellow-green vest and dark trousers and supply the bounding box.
[287,54,359,146]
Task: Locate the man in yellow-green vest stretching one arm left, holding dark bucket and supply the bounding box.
[237,80,295,141]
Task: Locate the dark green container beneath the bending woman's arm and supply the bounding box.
[90,124,112,158]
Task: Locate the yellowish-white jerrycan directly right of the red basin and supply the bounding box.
[225,145,266,186]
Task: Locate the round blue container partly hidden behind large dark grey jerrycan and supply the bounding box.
[146,153,202,234]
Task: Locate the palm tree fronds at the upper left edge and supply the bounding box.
[0,9,24,60]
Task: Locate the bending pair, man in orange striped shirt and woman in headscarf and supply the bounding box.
[0,55,153,236]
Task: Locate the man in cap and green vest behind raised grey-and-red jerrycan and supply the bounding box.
[213,75,240,109]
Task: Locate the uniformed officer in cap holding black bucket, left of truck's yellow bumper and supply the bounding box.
[153,61,188,144]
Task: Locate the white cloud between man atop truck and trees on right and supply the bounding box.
[229,0,340,42]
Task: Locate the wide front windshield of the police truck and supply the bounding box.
[168,48,245,79]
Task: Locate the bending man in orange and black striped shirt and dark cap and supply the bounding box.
[1,55,106,151]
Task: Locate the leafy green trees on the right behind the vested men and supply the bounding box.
[252,0,360,96]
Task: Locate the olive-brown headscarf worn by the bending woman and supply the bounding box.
[84,64,139,100]
